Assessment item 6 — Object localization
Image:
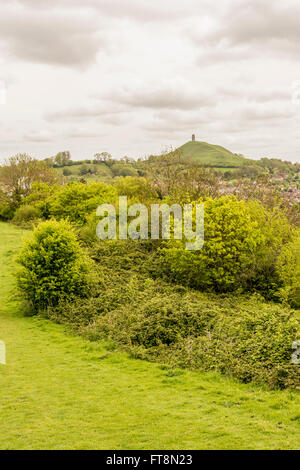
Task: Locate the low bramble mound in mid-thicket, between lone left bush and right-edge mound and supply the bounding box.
[98,288,214,346]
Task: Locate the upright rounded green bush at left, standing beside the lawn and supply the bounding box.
[17,220,89,311]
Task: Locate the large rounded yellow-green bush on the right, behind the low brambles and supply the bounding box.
[162,196,291,292]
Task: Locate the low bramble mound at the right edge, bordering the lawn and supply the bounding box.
[159,299,300,388]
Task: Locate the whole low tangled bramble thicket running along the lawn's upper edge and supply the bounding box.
[48,241,300,388]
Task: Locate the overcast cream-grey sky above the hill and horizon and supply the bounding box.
[0,0,300,162]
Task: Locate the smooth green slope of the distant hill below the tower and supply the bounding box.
[178,141,248,168]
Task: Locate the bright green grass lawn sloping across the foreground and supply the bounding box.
[0,223,300,449]
